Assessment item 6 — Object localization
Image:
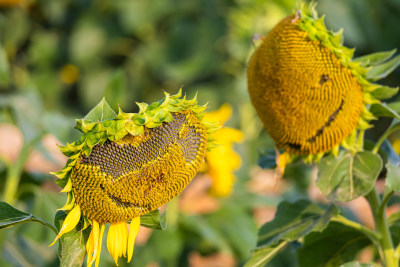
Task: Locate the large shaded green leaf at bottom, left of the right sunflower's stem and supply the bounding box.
[245,200,339,266]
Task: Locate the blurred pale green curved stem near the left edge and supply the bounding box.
[3,134,43,205]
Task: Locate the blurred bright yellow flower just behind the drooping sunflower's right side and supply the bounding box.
[205,104,244,197]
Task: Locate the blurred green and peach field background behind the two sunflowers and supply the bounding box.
[0,0,400,267]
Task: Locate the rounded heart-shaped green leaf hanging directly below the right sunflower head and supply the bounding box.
[316,151,382,202]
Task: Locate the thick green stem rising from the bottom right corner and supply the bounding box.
[366,188,399,267]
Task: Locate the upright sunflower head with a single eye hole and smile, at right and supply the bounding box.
[248,3,393,165]
